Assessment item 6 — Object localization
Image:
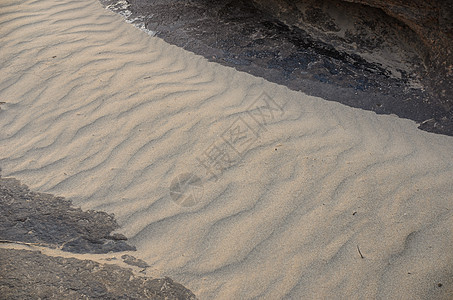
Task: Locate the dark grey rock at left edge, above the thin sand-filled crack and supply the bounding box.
[0,177,135,253]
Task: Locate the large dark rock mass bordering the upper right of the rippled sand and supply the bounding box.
[100,0,453,135]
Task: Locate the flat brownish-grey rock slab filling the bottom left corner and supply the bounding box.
[0,249,196,299]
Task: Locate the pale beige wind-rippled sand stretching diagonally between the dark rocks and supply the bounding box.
[0,0,453,299]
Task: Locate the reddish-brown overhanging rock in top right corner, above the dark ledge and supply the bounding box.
[253,0,453,118]
